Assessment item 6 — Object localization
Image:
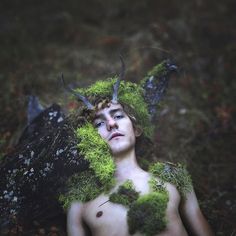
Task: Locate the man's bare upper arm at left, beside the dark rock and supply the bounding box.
[67,202,86,236]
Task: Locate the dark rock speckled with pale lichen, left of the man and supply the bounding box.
[0,104,88,235]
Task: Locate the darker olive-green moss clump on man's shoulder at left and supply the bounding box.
[59,171,103,209]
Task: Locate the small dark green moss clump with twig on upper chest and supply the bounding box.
[109,180,139,207]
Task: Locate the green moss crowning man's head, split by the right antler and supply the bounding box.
[76,78,154,137]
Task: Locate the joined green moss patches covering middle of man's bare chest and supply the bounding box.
[109,178,169,236]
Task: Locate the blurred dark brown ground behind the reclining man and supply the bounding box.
[0,0,236,235]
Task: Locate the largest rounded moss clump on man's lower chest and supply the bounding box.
[128,192,168,236]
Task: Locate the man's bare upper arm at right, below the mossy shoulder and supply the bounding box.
[180,190,214,236]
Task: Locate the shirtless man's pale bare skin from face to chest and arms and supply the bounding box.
[67,103,213,236]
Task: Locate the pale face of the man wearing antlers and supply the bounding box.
[94,103,135,156]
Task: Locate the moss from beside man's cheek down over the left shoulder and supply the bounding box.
[59,123,115,208]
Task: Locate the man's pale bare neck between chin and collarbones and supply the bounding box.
[114,150,143,183]
